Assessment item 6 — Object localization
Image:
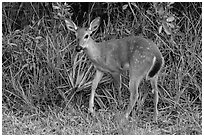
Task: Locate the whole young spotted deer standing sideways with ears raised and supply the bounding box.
[65,17,164,121]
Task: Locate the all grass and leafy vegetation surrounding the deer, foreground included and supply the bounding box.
[2,3,202,135]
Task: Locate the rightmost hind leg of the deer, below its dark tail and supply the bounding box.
[150,75,159,122]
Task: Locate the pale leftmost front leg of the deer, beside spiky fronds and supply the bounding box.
[89,70,103,114]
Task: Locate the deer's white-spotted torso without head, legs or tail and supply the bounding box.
[85,36,161,73]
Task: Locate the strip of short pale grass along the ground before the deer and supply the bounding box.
[2,102,201,135]
